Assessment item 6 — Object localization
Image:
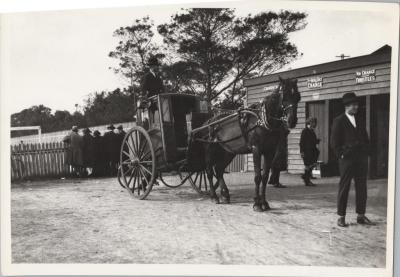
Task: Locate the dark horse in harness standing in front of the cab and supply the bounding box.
[196,78,300,211]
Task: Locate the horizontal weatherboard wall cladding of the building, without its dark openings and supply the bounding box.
[245,60,390,173]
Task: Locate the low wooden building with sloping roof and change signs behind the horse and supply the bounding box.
[244,45,391,177]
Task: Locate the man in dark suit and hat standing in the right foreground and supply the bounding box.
[331,92,372,227]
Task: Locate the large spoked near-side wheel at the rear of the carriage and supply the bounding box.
[120,126,156,199]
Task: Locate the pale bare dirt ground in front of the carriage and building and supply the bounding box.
[11,173,387,267]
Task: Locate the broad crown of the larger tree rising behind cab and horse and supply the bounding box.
[158,9,306,104]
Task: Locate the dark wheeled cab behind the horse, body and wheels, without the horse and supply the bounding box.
[119,93,216,199]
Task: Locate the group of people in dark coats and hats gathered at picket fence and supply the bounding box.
[63,124,125,177]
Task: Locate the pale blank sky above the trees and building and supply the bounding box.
[0,1,398,113]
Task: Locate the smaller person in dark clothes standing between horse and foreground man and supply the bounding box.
[300,117,319,186]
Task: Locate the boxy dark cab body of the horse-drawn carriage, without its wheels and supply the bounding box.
[143,93,210,172]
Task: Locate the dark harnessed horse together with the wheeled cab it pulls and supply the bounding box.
[119,76,300,210]
